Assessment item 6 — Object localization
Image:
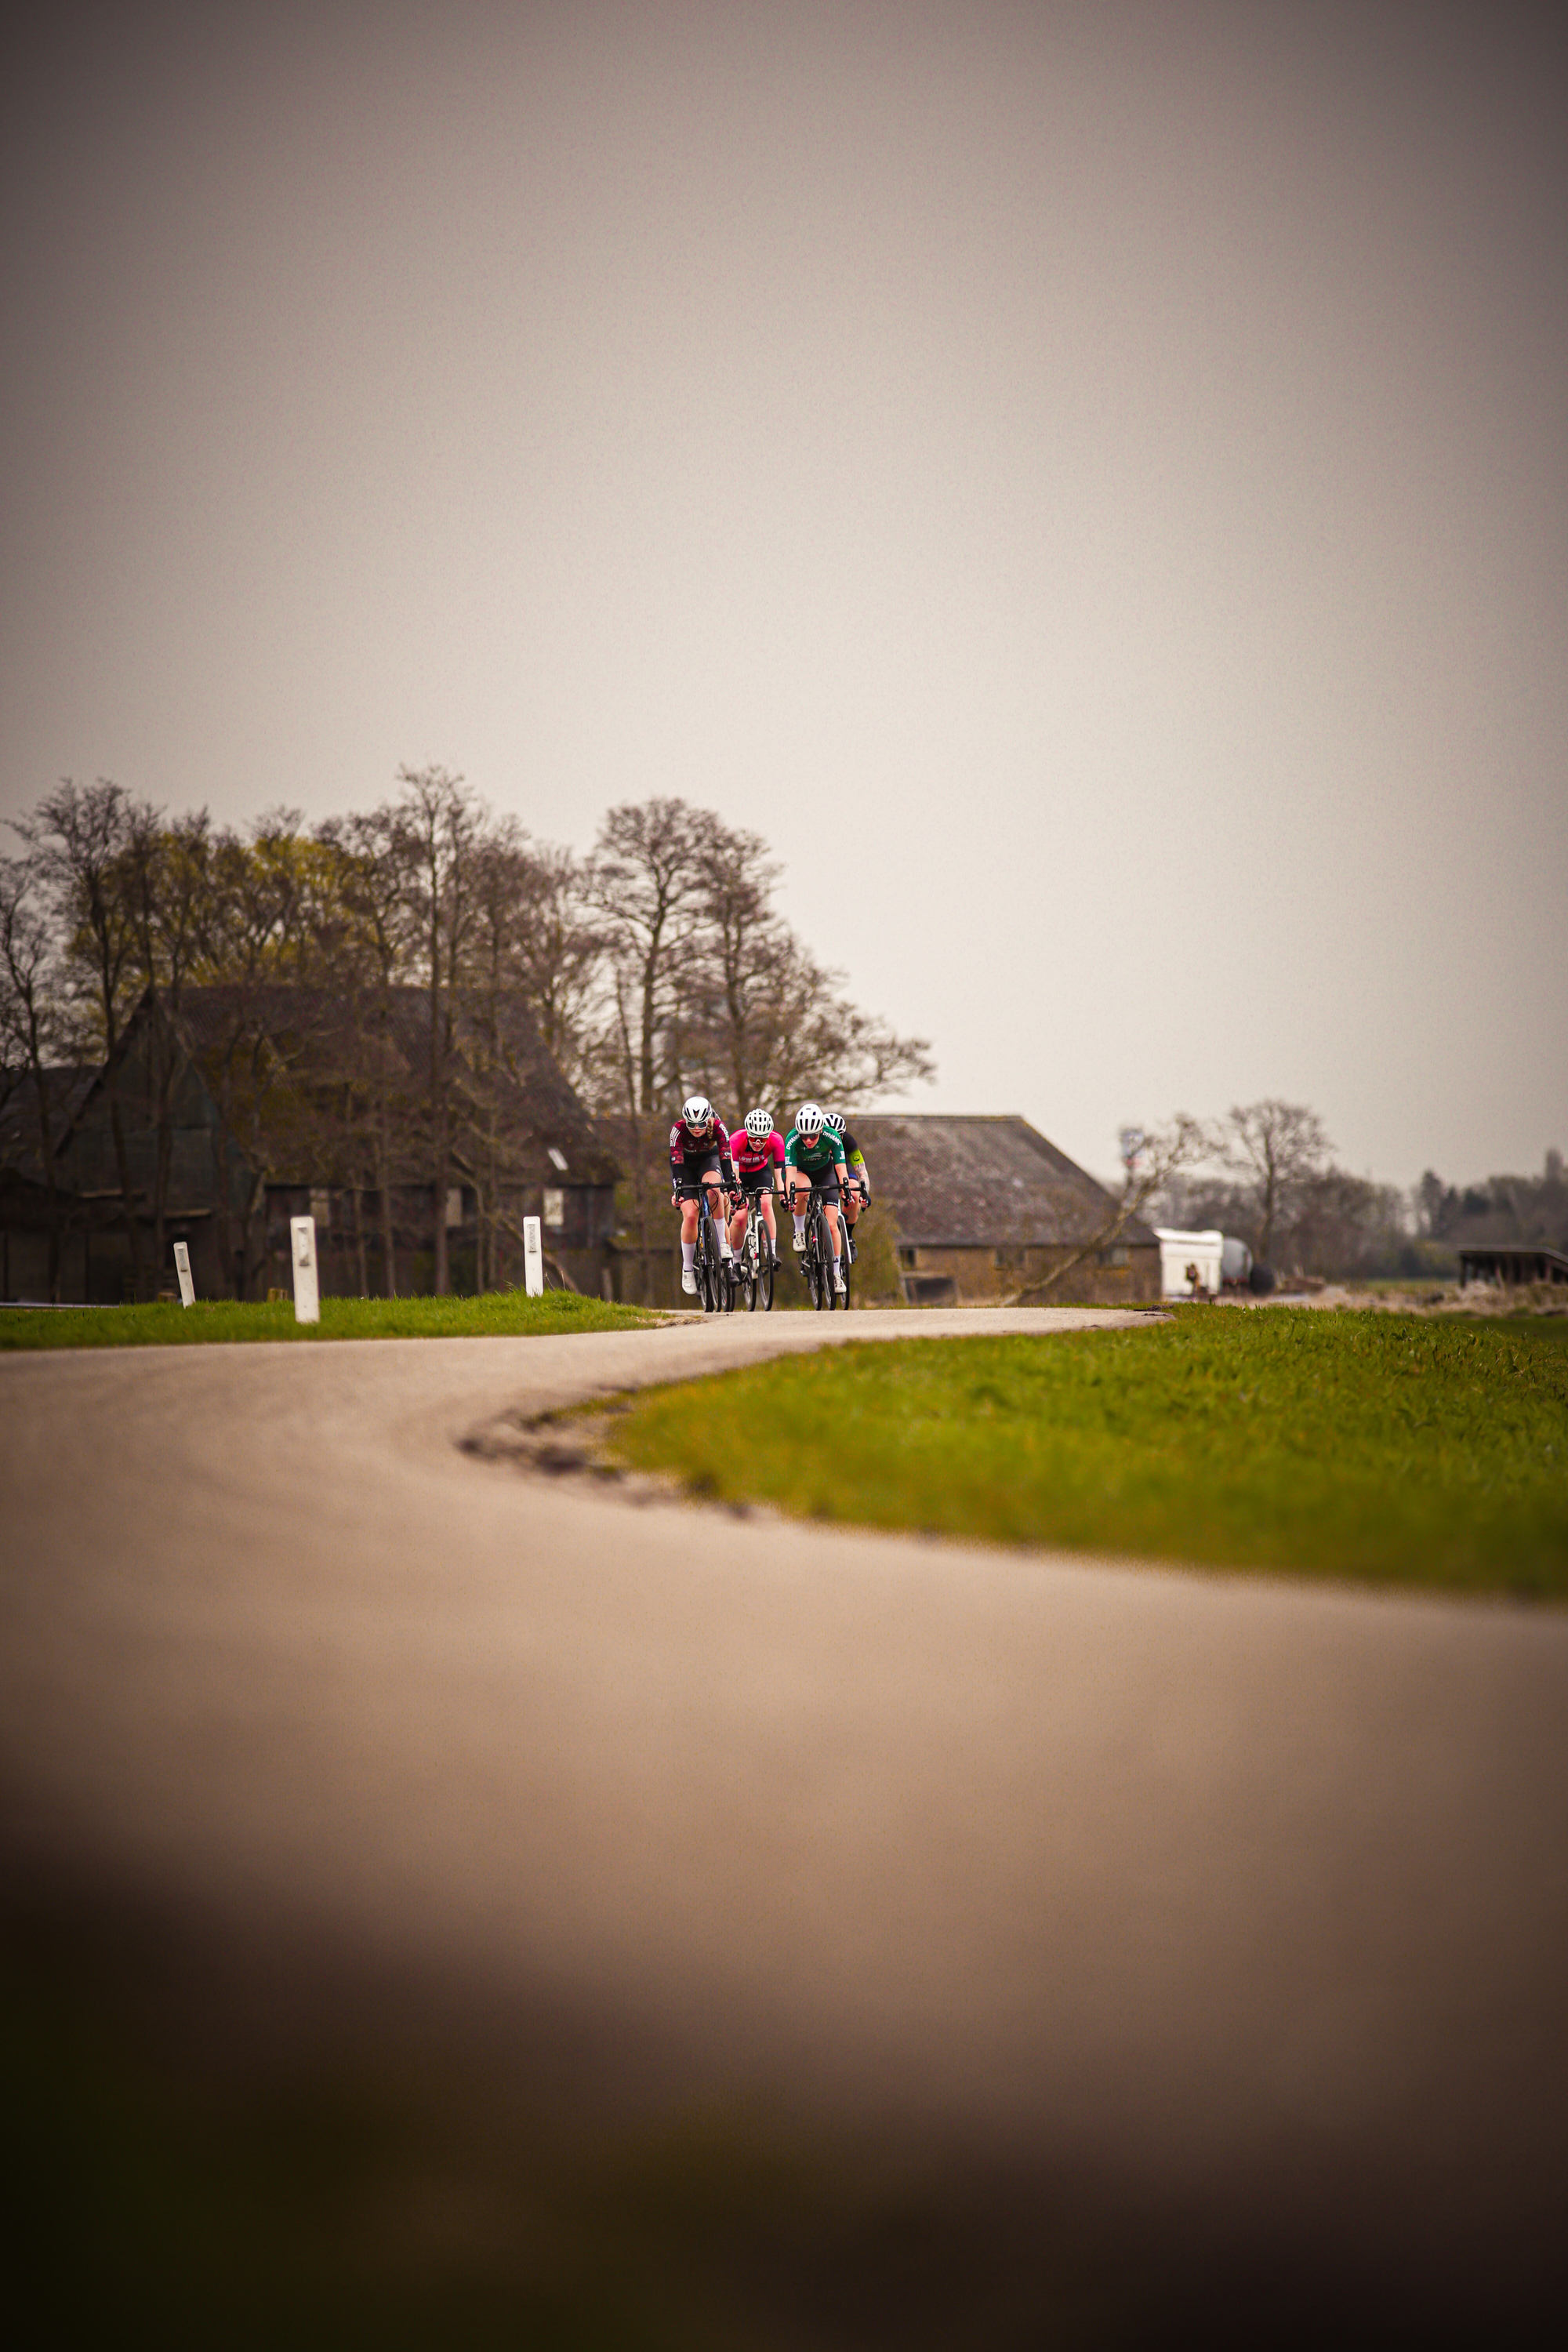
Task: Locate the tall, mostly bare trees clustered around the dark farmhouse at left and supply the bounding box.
[0,767,931,1291]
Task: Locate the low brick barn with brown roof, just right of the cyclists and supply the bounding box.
[851,1112,1159,1305]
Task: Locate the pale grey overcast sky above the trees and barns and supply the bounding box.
[0,0,1568,1183]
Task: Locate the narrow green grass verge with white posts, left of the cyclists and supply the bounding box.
[0,1291,654,1350]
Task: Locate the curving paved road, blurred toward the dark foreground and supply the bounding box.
[0,1310,1568,2291]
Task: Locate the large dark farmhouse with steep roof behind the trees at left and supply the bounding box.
[0,985,619,1303]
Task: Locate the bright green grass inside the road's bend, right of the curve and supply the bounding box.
[612,1308,1568,1599]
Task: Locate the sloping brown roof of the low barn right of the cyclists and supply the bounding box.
[848,1112,1159,1249]
